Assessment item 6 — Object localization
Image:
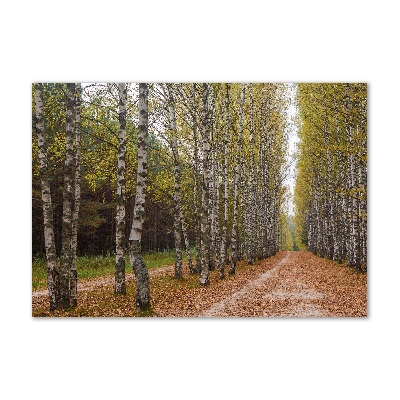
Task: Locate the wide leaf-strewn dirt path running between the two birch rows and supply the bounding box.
[199,251,367,317]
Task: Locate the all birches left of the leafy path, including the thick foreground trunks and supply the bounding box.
[33,83,287,311]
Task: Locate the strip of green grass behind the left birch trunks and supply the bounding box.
[32,250,192,290]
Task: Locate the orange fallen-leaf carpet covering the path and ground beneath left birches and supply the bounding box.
[32,251,367,317]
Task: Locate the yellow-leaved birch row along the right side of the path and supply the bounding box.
[295,83,367,271]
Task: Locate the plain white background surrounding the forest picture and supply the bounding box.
[0,0,400,400]
